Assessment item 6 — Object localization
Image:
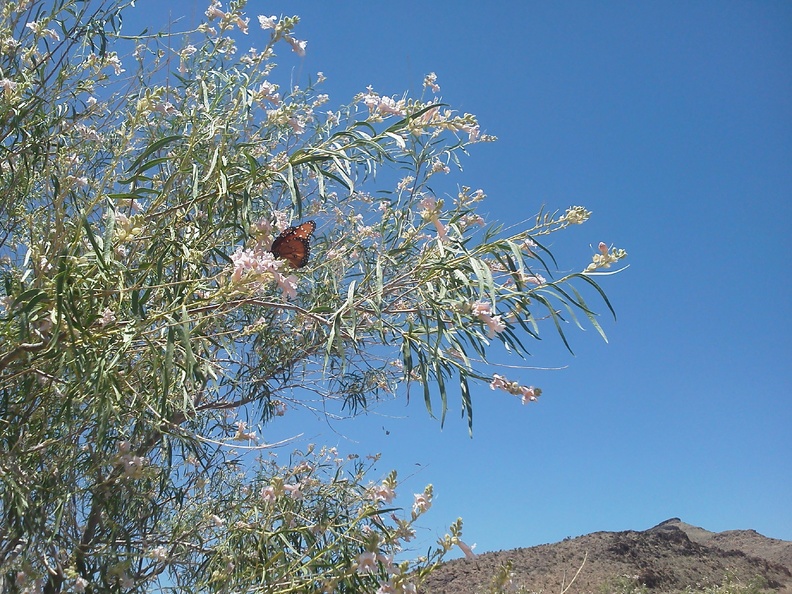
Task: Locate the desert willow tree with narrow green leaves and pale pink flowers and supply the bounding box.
[0,0,624,593]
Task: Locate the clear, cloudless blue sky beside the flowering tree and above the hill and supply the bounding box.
[126,0,792,552]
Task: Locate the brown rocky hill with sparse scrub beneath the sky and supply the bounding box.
[423,518,792,594]
